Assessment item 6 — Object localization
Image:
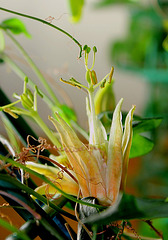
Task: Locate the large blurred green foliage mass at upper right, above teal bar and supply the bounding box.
[111,7,168,82]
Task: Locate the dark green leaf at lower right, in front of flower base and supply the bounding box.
[83,194,168,226]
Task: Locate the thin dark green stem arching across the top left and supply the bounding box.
[0,7,82,58]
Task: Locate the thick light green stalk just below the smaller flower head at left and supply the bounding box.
[31,111,61,148]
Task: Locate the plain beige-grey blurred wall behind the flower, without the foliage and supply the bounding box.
[0,0,148,135]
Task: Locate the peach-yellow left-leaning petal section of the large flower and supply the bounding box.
[50,113,105,201]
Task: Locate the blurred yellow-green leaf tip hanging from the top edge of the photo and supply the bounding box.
[68,0,84,22]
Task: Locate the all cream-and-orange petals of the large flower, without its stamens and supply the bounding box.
[27,99,135,206]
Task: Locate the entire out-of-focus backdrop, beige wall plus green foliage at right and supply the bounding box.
[0,0,168,237]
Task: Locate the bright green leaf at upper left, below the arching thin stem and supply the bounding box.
[0,18,31,38]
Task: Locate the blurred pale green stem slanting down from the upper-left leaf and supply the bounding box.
[6,31,60,105]
